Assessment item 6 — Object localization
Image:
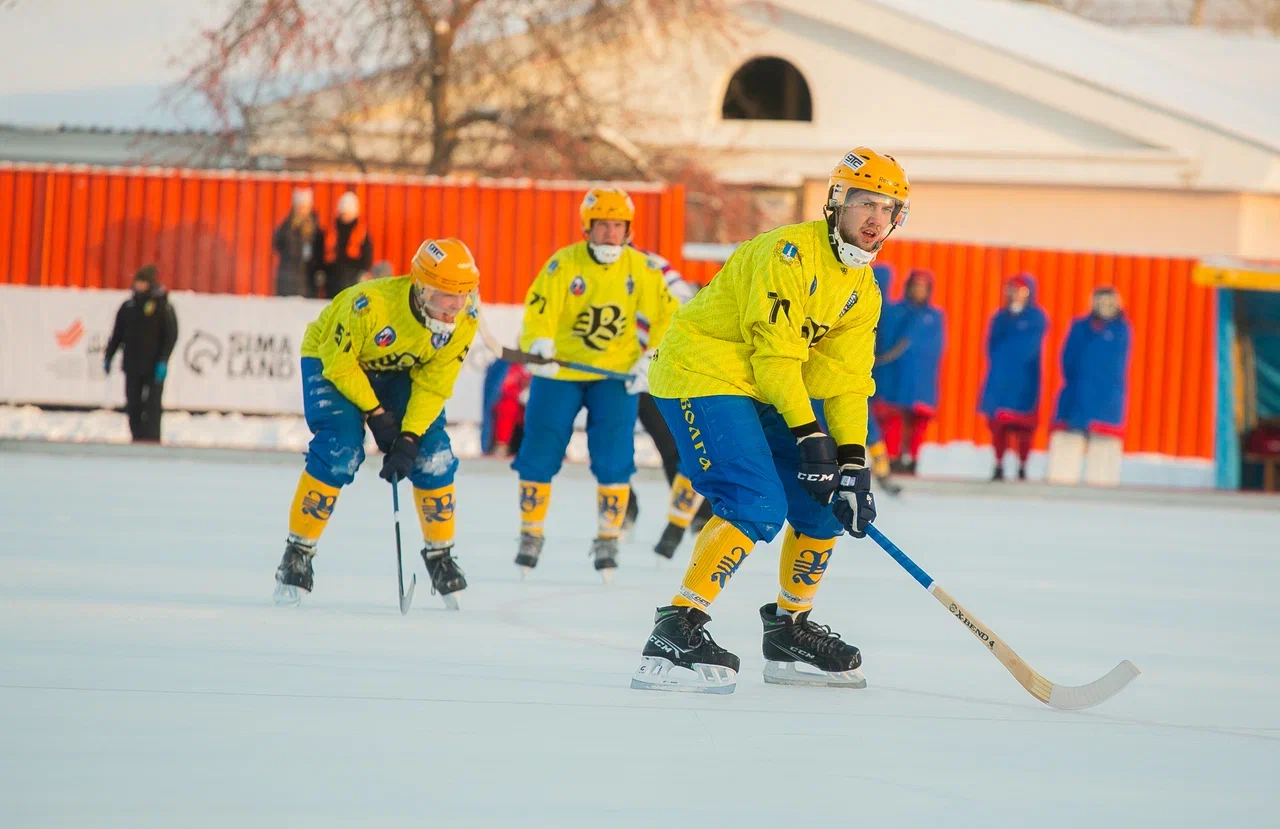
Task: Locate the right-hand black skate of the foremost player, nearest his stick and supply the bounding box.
[760,604,867,688]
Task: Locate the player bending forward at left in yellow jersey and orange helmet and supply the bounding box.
[275,239,480,608]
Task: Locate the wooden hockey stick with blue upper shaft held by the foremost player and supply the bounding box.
[867,525,1142,711]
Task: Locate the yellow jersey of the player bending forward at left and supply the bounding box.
[302,276,479,435]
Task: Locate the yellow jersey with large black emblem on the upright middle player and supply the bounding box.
[520,242,678,381]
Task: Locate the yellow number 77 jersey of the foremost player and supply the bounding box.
[649,220,881,445]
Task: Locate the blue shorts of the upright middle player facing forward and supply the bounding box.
[511,376,640,485]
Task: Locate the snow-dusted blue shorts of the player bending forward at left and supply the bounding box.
[302,357,458,489]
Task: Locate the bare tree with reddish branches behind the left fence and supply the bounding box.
[180,0,747,179]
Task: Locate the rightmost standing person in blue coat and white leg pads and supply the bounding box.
[1048,287,1132,486]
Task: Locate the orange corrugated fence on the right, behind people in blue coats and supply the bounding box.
[684,241,1216,458]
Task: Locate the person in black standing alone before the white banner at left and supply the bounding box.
[102,265,178,443]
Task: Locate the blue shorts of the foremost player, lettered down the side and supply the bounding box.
[654,394,844,541]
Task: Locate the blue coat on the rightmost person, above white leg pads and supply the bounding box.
[1053,312,1133,436]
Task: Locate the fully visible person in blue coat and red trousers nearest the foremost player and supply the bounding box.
[872,269,947,475]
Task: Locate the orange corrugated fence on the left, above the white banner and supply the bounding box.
[0,164,685,303]
